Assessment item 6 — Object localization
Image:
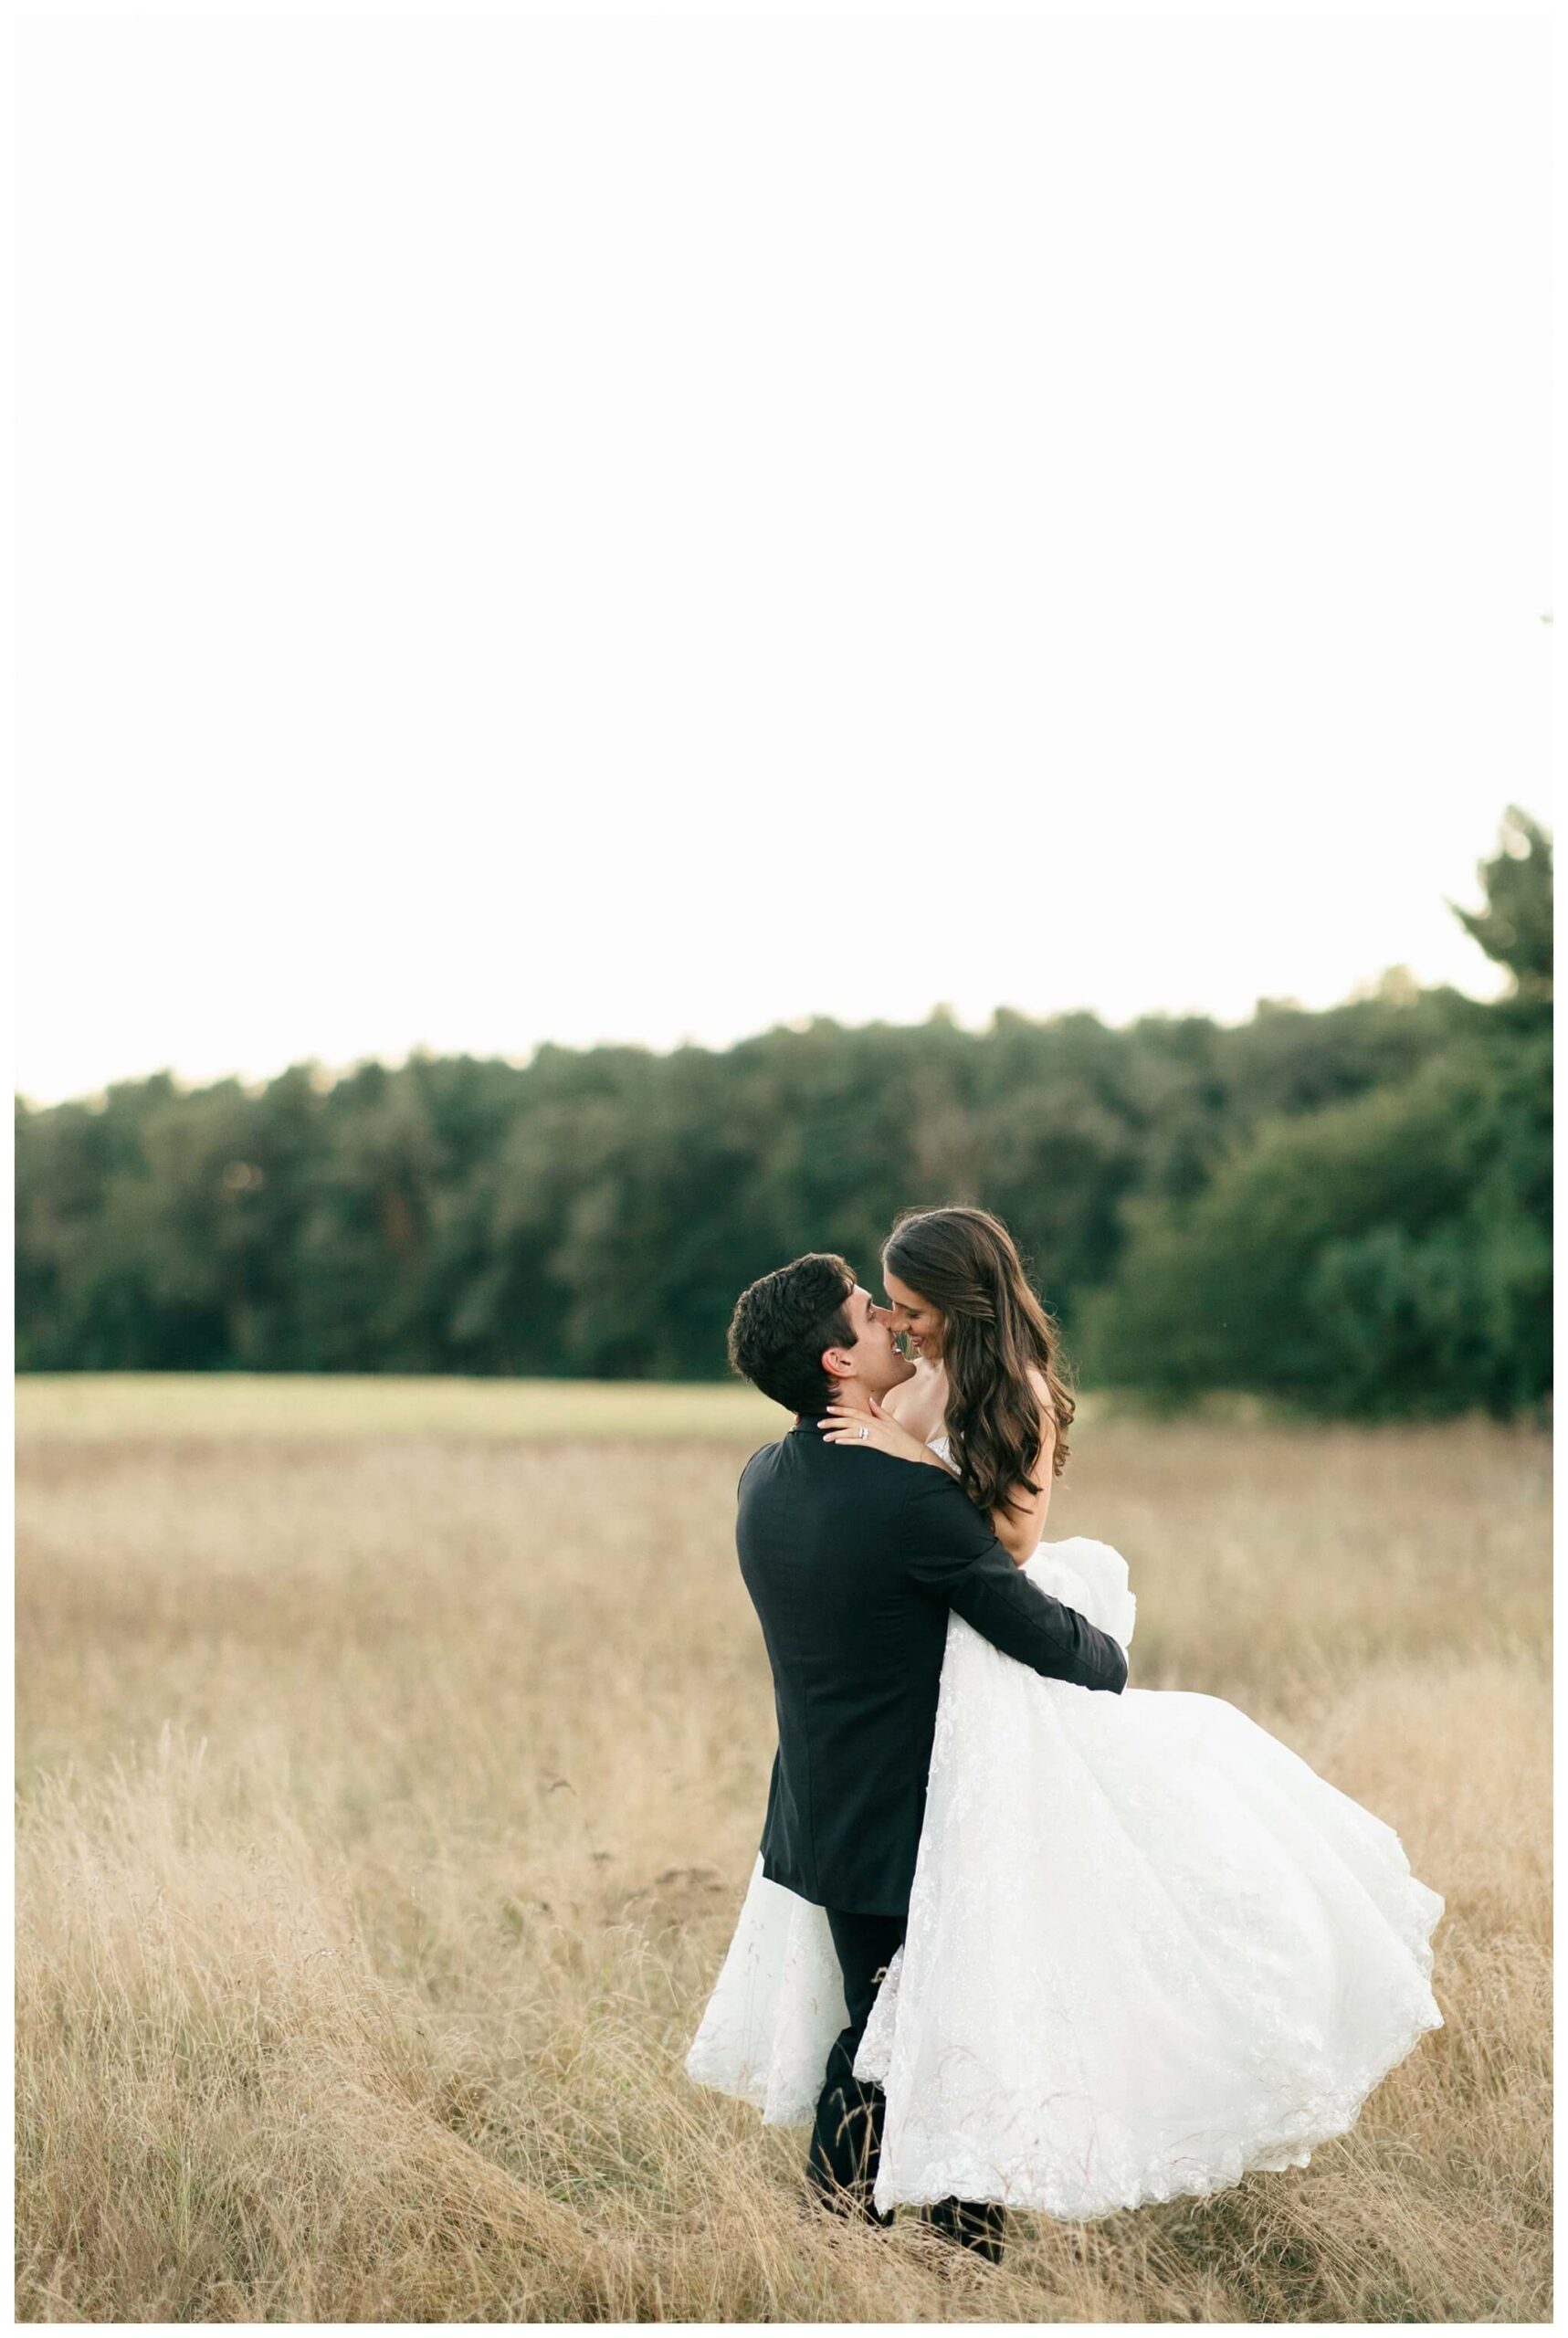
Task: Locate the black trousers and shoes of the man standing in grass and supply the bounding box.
[806,1908,1005,2263]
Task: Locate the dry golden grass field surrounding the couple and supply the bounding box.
[16,1379,1552,2322]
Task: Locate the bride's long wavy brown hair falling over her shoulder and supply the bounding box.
[881,1204,1075,1511]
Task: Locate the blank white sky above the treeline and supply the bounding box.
[14,16,1552,1101]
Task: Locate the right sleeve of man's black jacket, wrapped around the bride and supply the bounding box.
[902,1469,1126,1695]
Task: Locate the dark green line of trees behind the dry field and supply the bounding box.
[16,811,1552,1419]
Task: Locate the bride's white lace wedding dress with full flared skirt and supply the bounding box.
[687,1440,1444,2218]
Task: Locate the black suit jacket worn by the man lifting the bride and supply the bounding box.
[736,1421,1126,1915]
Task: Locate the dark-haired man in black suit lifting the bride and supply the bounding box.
[729,1253,1126,2261]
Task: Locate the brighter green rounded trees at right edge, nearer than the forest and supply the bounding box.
[1084,814,1552,1419]
